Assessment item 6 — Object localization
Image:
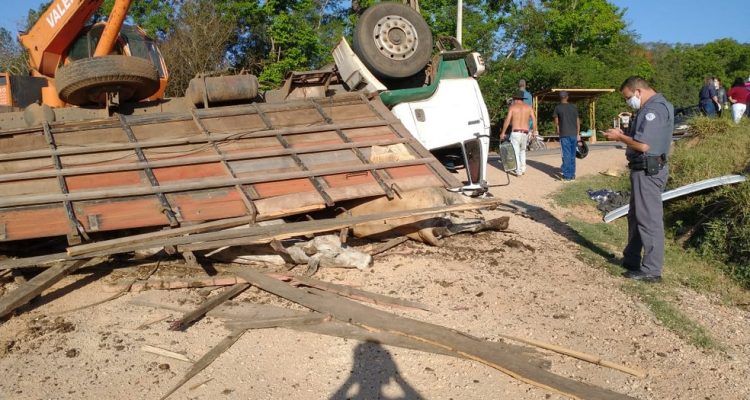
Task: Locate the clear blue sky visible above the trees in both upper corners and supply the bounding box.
[0,0,750,44]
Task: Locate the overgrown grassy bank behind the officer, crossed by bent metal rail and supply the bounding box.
[666,117,750,288]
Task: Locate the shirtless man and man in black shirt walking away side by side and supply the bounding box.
[500,79,581,182]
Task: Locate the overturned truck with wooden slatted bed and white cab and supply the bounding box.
[0,3,489,250]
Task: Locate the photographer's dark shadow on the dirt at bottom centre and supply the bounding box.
[330,342,423,400]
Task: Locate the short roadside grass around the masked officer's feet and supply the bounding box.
[553,176,750,350]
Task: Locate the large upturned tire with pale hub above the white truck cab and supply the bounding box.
[352,2,432,78]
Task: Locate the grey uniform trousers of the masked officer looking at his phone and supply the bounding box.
[623,165,669,276]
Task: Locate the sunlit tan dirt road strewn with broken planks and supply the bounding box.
[0,148,750,399]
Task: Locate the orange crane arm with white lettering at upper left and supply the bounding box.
[20,0,132,77]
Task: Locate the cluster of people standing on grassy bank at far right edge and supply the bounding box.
[698,77,750,124]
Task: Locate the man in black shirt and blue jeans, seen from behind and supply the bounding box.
[553,91,581,181]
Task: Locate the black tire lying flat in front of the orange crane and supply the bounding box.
[55,55,159,106]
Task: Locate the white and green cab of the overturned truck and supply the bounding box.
[333,39,490,196]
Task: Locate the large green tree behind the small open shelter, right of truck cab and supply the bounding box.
[488,0,653,129]
